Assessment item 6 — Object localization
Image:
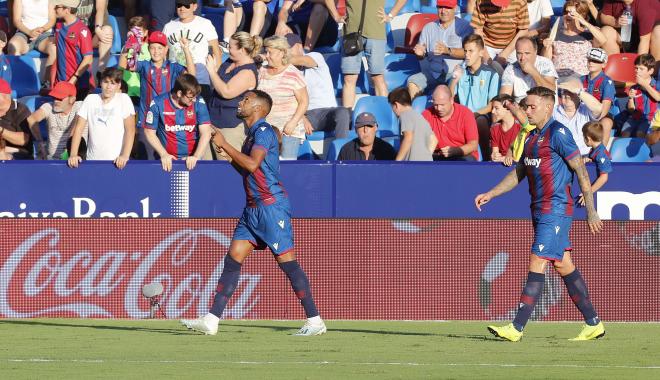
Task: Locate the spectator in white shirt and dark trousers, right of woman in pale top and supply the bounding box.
[286,33,351,138]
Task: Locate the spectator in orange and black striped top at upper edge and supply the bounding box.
[471,0,529,65]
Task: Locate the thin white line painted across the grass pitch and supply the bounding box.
[0,358,660,369]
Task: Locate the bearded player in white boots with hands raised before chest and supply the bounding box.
[181,90,326,336]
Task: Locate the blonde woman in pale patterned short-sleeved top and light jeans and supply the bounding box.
[257,36,312,160]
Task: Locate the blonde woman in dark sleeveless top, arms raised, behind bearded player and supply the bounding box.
[206,32,262,159]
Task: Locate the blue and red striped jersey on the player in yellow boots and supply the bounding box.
[522,119,580,216]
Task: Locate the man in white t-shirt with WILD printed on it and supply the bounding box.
[163,0,222,103]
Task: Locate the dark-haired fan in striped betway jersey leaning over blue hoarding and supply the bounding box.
[144,74,212,171]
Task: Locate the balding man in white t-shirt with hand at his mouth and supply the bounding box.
[500,37,558,102]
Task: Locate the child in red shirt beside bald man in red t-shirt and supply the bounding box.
[490,95,522,162]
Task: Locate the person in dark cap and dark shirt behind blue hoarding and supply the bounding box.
[338,112,396,161]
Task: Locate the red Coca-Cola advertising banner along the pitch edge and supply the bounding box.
[0,219,660,321]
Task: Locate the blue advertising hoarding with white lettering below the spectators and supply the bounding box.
[0,161,660,220]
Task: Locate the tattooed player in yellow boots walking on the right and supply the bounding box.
[474,87,605,342]
